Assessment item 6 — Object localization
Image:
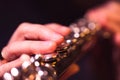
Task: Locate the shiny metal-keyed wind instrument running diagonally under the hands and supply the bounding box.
[2,18,100,80]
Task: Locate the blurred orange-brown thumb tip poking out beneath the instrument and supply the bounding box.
[59,64,80,80]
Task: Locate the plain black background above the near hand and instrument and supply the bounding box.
[0,0,104,48]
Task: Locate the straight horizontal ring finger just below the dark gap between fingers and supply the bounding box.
[2,41,57,60]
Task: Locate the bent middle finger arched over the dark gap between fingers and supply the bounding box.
[9,23,64,44]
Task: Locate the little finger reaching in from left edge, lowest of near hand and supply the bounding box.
[0,54,30,77]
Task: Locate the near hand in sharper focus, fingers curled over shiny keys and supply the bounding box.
[0,23,70,77]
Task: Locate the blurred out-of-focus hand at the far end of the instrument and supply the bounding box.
[86,1,120,46]
